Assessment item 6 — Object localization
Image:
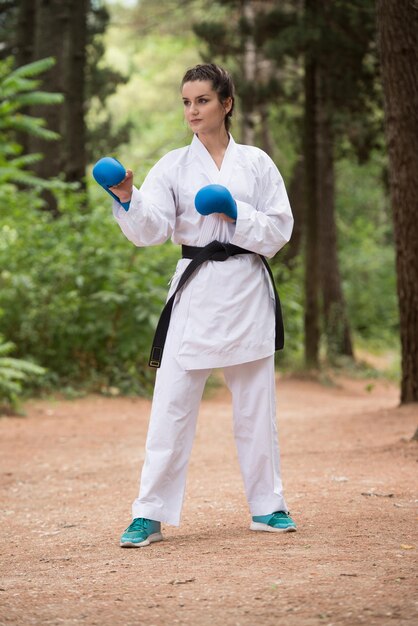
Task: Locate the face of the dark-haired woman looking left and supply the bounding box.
[182,80,232,135]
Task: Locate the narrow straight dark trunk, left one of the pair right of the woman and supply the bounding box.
[304,12,319,368]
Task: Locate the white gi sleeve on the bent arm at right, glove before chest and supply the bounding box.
[231,151,293,258]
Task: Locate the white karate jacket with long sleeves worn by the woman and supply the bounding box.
[113,135,293,370]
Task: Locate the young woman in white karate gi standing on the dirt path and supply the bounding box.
[112,64,296,547]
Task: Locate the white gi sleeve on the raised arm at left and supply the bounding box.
[113,159,176,247]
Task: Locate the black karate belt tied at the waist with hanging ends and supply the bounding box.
[149,241,284,368]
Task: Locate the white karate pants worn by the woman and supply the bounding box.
[132,351,288,526]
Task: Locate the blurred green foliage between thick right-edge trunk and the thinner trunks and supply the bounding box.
[337,153,399,347]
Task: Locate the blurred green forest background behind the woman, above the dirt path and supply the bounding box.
[0,0,417,407]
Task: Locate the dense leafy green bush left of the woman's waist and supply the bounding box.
[0,186,178,393]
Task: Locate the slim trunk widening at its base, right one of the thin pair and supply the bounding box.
[317,67,353,362]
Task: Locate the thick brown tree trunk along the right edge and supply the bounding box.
[377,0,418,403]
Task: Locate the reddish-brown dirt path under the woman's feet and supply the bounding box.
[0,372,418,626]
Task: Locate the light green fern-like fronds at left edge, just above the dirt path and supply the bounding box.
[0,335,45,415]
